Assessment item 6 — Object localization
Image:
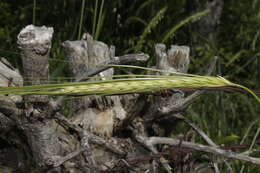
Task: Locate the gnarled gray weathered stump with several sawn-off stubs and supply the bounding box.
[0,25,230,172]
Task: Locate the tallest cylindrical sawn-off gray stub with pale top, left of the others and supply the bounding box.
[17,25,61,167]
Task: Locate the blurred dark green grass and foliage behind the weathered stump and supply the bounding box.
[0,0,260,172]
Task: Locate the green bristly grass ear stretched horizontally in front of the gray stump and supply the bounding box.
[0,73,260,102]
